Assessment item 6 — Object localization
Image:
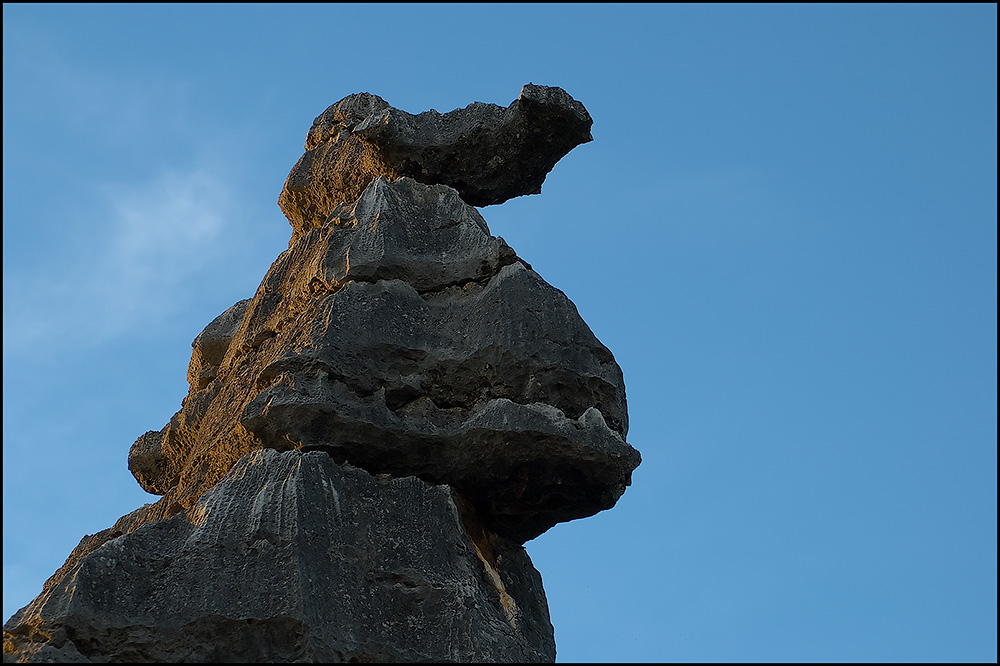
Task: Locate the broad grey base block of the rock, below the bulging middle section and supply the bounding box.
[4,449,555,662]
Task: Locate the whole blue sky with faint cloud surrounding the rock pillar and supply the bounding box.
[3,4,997,661]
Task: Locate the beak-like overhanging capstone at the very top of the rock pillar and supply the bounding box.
[278,83,593,238]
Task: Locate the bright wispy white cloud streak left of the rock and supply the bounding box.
[4,166,237,356]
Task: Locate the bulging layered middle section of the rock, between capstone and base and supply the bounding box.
[129,177,639,543]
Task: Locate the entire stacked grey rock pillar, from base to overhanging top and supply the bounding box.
[4,85,640,662]
